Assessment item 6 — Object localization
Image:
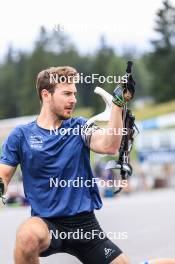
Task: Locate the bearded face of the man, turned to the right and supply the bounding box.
[49,83,77,120]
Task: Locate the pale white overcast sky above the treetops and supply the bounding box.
[0,0,175,60]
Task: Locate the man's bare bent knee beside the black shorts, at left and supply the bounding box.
[16,218,50,255]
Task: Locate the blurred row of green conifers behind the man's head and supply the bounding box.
[0,27,150,118]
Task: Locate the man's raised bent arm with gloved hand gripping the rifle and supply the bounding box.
[86,61,135,154]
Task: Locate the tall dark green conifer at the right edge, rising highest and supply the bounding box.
[147,0,175,102]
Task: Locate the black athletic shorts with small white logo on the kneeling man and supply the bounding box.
[40,212,122,264]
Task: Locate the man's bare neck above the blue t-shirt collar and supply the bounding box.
[36,108,63,130]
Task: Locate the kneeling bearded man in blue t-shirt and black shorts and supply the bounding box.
[0,67,173,264]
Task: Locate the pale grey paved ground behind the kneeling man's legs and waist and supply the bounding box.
[0,189,175,264]
